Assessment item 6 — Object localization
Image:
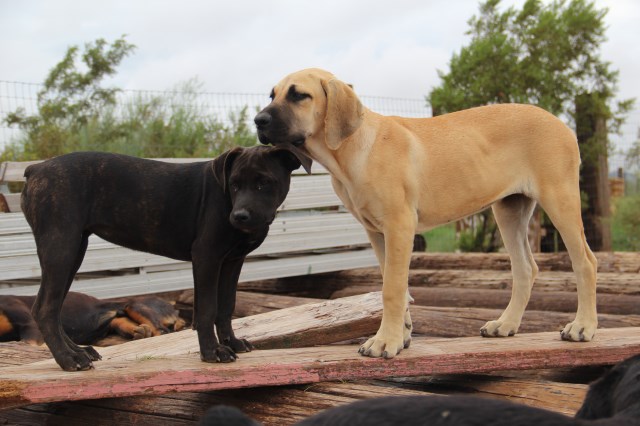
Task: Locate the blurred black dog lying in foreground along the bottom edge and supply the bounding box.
[200,355,640,426]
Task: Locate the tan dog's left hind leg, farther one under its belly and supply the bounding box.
[480,194,538,337]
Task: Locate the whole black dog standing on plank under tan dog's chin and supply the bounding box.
[22,147,305,371]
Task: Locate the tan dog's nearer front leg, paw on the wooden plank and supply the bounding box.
[359,221,415,359]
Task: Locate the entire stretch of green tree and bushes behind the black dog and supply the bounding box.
[0,37,257,161]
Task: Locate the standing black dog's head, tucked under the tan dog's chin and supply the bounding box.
[213,146,301,232]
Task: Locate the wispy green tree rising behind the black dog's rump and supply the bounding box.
[6,36,135,159]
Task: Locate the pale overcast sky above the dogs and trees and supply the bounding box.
[0,0,640,150]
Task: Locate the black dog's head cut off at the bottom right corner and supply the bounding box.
[576,355,640,421]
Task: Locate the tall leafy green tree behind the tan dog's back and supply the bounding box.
[427,0,633,250]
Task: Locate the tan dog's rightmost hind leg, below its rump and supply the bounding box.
[540,183,598,342]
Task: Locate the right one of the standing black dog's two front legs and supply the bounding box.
[216,256,254,352]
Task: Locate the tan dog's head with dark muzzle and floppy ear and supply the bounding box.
[254,68,364,163]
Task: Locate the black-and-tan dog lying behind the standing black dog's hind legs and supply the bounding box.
[0,291,185,345]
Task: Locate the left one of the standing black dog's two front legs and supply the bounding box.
[193,255,237,362]
